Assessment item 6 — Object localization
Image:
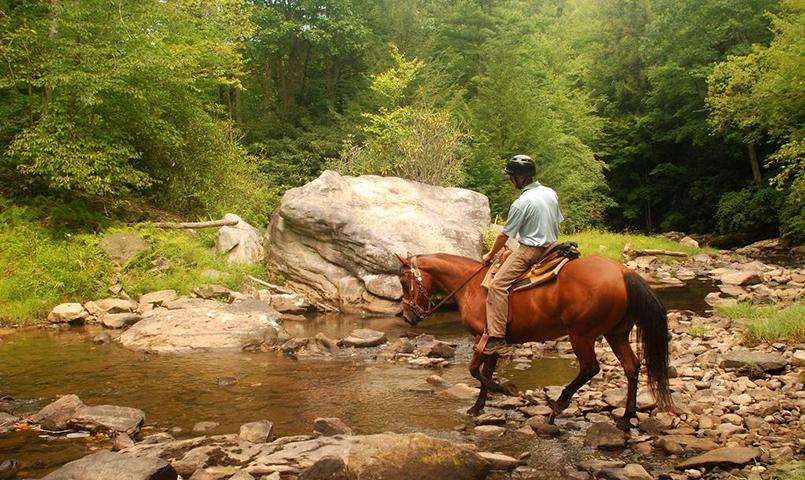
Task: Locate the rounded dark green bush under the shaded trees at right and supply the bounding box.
[716,187,783,237]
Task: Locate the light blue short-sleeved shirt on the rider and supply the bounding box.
[503,182,565,247]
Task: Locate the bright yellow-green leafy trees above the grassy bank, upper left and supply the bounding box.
[0,0,264,222]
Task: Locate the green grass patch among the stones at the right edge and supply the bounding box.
[716,302,805,345]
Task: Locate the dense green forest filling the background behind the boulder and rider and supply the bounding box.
[0,0,805,240]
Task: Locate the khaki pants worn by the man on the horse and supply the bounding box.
[486,244,545,338]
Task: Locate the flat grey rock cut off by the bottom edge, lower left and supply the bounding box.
[42,450,177,480]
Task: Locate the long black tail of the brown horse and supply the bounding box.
[623,272,673,409]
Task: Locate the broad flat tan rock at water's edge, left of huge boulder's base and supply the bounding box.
[119,304,280,354]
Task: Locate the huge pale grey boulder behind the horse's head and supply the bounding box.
[268,170,490,313]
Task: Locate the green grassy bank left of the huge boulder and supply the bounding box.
[0,198,265,325]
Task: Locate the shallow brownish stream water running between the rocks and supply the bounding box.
[0,283,711,478]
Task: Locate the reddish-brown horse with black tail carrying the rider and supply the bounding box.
[399,253,671,428]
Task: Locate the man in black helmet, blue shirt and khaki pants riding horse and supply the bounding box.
[483,155,564,355]
